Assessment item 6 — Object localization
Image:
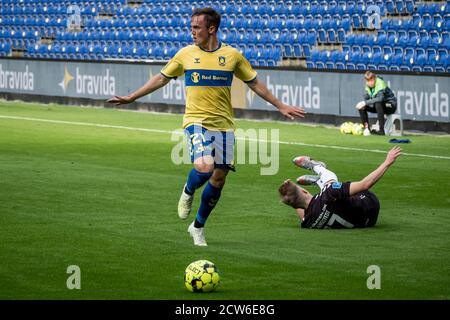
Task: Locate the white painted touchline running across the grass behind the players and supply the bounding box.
[0,115,450,160]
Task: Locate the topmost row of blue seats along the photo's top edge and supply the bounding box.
[0,0,449,16]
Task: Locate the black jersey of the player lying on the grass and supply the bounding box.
[301,182,380,229]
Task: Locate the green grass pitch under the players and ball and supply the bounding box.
[0,101,450,300]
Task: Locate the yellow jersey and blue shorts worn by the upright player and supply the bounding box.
[161,44,256,170]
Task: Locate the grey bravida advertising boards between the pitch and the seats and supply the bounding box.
[0,58,450,133]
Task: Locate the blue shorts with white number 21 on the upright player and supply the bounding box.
[184,124,236,171]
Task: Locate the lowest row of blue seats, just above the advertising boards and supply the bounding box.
[0,44,450,71]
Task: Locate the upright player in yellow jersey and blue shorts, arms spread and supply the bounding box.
[108,8,305,246]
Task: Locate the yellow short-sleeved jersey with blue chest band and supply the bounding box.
[161,43,256,131]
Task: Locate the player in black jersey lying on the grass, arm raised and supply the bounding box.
[278,147,402,229]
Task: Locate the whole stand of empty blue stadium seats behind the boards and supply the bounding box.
[0,0,450,71]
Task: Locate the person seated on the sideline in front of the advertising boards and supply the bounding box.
[356,71,397,135]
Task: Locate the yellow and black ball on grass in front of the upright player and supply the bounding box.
[184,260,220,292]
